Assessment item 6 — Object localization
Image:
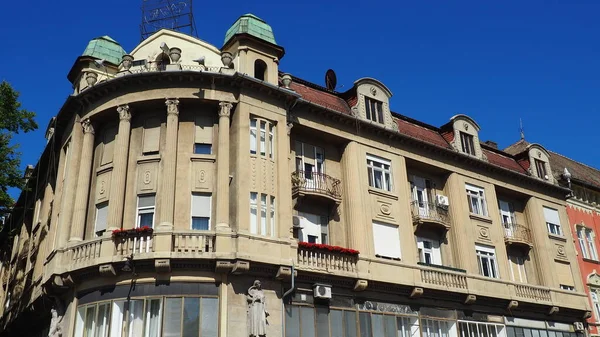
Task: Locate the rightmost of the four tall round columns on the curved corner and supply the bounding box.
[216,102,233,229]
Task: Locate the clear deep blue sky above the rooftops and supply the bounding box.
[0,0,600,197]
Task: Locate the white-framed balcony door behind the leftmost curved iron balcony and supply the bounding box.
[296,142,325,189]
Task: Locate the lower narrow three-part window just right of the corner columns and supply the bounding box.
[250,192,277,237]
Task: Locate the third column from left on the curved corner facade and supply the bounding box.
[159,98,179,230]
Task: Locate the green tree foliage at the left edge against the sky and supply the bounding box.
[0,81,38,216]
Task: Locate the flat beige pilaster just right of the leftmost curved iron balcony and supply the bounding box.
[342,141,373,255]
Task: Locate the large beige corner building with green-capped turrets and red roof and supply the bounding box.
[0,11,591,337]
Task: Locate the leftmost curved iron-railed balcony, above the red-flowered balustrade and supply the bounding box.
[292,171,342,205]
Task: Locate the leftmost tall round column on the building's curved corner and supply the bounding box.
[69,118,94,242]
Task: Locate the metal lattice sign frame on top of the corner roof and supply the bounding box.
[140,0,196,40]
